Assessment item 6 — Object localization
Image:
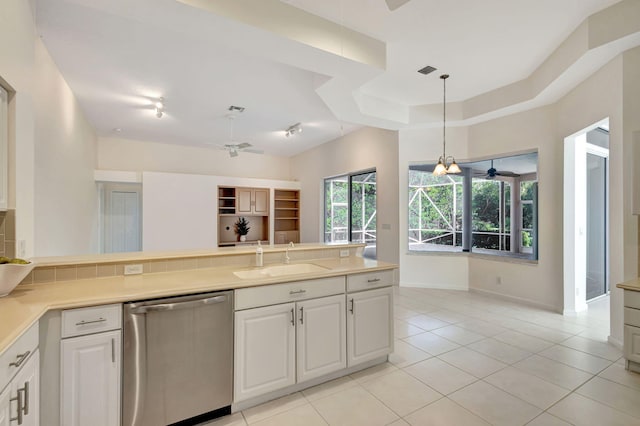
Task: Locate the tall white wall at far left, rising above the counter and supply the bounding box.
[0,0,97,257]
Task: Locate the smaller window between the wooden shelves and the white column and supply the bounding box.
[324,171,377,257]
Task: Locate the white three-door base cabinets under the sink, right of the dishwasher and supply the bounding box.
[234,271,393,404]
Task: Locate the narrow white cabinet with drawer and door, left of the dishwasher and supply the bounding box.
[60,304,122,426]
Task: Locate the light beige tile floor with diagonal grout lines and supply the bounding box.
[208,288,640,426]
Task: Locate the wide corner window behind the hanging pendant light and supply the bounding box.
[408,153,538,259]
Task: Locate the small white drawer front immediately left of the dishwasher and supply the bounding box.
[62,304,122,338]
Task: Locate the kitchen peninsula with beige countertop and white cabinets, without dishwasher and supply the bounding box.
[0,244,397,425]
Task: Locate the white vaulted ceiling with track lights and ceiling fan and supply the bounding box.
[36,0,617,156]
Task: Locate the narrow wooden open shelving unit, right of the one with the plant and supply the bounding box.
[273,189,300,244]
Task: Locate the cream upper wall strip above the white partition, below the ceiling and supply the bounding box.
[98,138,290,180]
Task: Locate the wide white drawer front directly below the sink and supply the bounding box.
[235,277,344,311]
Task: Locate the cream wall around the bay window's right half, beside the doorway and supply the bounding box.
[469,106,564,310]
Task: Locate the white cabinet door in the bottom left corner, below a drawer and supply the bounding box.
[11,350,40,426]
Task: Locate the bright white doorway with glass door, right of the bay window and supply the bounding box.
[563,119,609,314]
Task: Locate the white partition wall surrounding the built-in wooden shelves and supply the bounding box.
[142,172,300,251]
